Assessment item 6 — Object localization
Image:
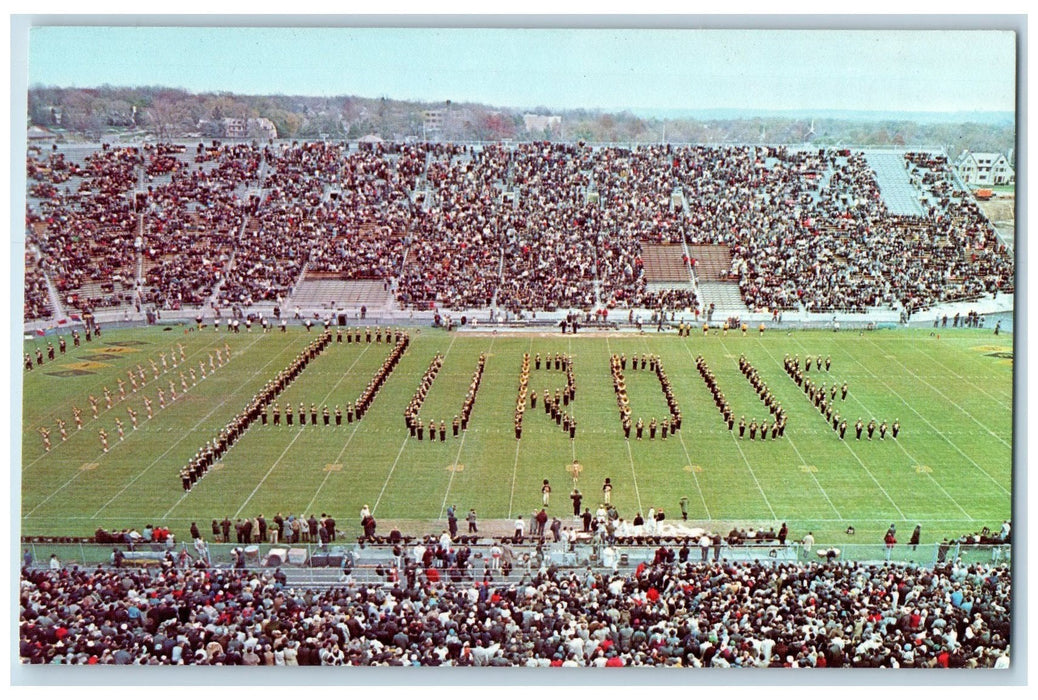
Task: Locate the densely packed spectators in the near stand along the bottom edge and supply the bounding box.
[19,547,1012,669]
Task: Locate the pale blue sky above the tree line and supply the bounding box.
[28,26,1016,112]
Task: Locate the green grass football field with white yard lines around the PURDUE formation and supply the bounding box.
[21,325,1013,542]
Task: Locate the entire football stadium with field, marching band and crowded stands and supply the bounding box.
[16,25,1016,669]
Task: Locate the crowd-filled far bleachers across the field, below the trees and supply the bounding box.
[26,141,1014,314]
